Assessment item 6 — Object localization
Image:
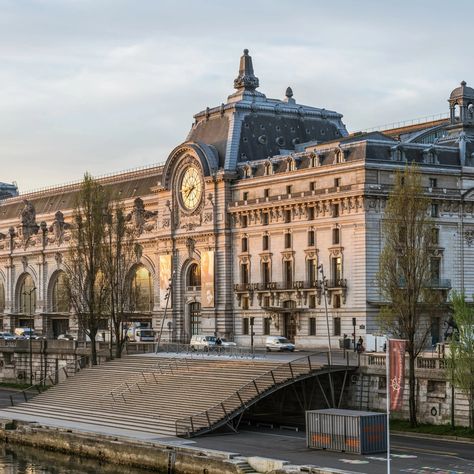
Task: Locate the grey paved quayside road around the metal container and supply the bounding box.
[192,429,474,474]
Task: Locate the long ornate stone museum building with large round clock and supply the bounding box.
[0,50,474,347]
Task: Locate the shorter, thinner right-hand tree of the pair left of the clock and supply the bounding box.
[102,202,138,357]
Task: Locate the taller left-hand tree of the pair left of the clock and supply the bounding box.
[65,173,110,365]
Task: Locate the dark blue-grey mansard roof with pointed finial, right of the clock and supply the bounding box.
[186,50,347,170]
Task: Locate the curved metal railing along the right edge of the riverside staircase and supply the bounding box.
[175,352,356,437]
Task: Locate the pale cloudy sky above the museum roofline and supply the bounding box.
[0,0,474,192]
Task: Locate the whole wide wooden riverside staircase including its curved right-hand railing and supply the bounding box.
[2,354,349,437]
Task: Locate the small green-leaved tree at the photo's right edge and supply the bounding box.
[448,290,474,429]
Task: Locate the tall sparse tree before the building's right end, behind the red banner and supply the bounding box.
[378,164,441,426]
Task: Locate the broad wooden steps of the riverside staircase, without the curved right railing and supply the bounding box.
[3,356,278,436]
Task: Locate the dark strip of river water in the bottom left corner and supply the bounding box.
[0,444,157,474]
